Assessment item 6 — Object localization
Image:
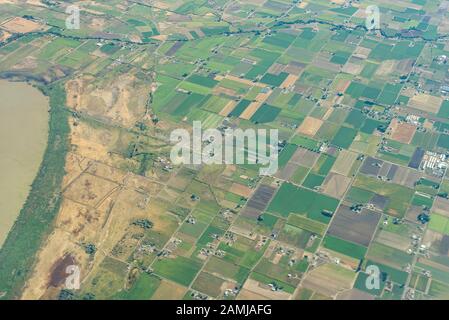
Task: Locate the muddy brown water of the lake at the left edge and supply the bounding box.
[0,80,49,247]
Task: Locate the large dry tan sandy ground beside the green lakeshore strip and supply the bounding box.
[23,55,169,299]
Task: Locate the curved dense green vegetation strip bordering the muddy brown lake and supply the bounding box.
[0,84,70,299]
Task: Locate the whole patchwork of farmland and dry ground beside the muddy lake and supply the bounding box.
[0,0,449,300]
